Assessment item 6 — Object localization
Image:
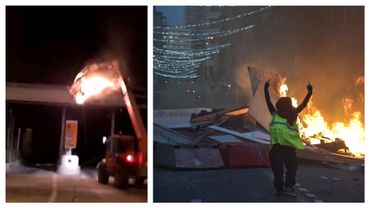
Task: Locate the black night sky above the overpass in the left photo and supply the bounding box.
[6,6,147,89]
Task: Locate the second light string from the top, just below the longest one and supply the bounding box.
[153,25,254,43]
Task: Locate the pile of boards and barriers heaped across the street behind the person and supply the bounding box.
[153,68,363,169]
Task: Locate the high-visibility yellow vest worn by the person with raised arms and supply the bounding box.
[270,113,304,149]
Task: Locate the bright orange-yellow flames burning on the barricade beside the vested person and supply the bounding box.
[279,79,365,157]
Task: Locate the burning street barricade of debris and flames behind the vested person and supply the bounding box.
[153,67,365,168]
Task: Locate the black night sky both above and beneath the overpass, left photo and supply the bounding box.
[6,6,147,166]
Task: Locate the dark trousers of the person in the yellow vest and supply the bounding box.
[270,144,297,191]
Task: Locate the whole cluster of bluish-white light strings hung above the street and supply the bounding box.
[153,6,270,79]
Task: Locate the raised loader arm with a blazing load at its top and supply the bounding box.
[69,61,147,184]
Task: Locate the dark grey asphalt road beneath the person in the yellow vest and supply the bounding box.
[153,164,364,202]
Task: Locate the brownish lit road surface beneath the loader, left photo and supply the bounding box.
[6,163,147,202]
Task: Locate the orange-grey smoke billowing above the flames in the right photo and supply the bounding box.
[231,7,364,122]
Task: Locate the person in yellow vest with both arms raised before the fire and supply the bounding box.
[265,80,312,195]
